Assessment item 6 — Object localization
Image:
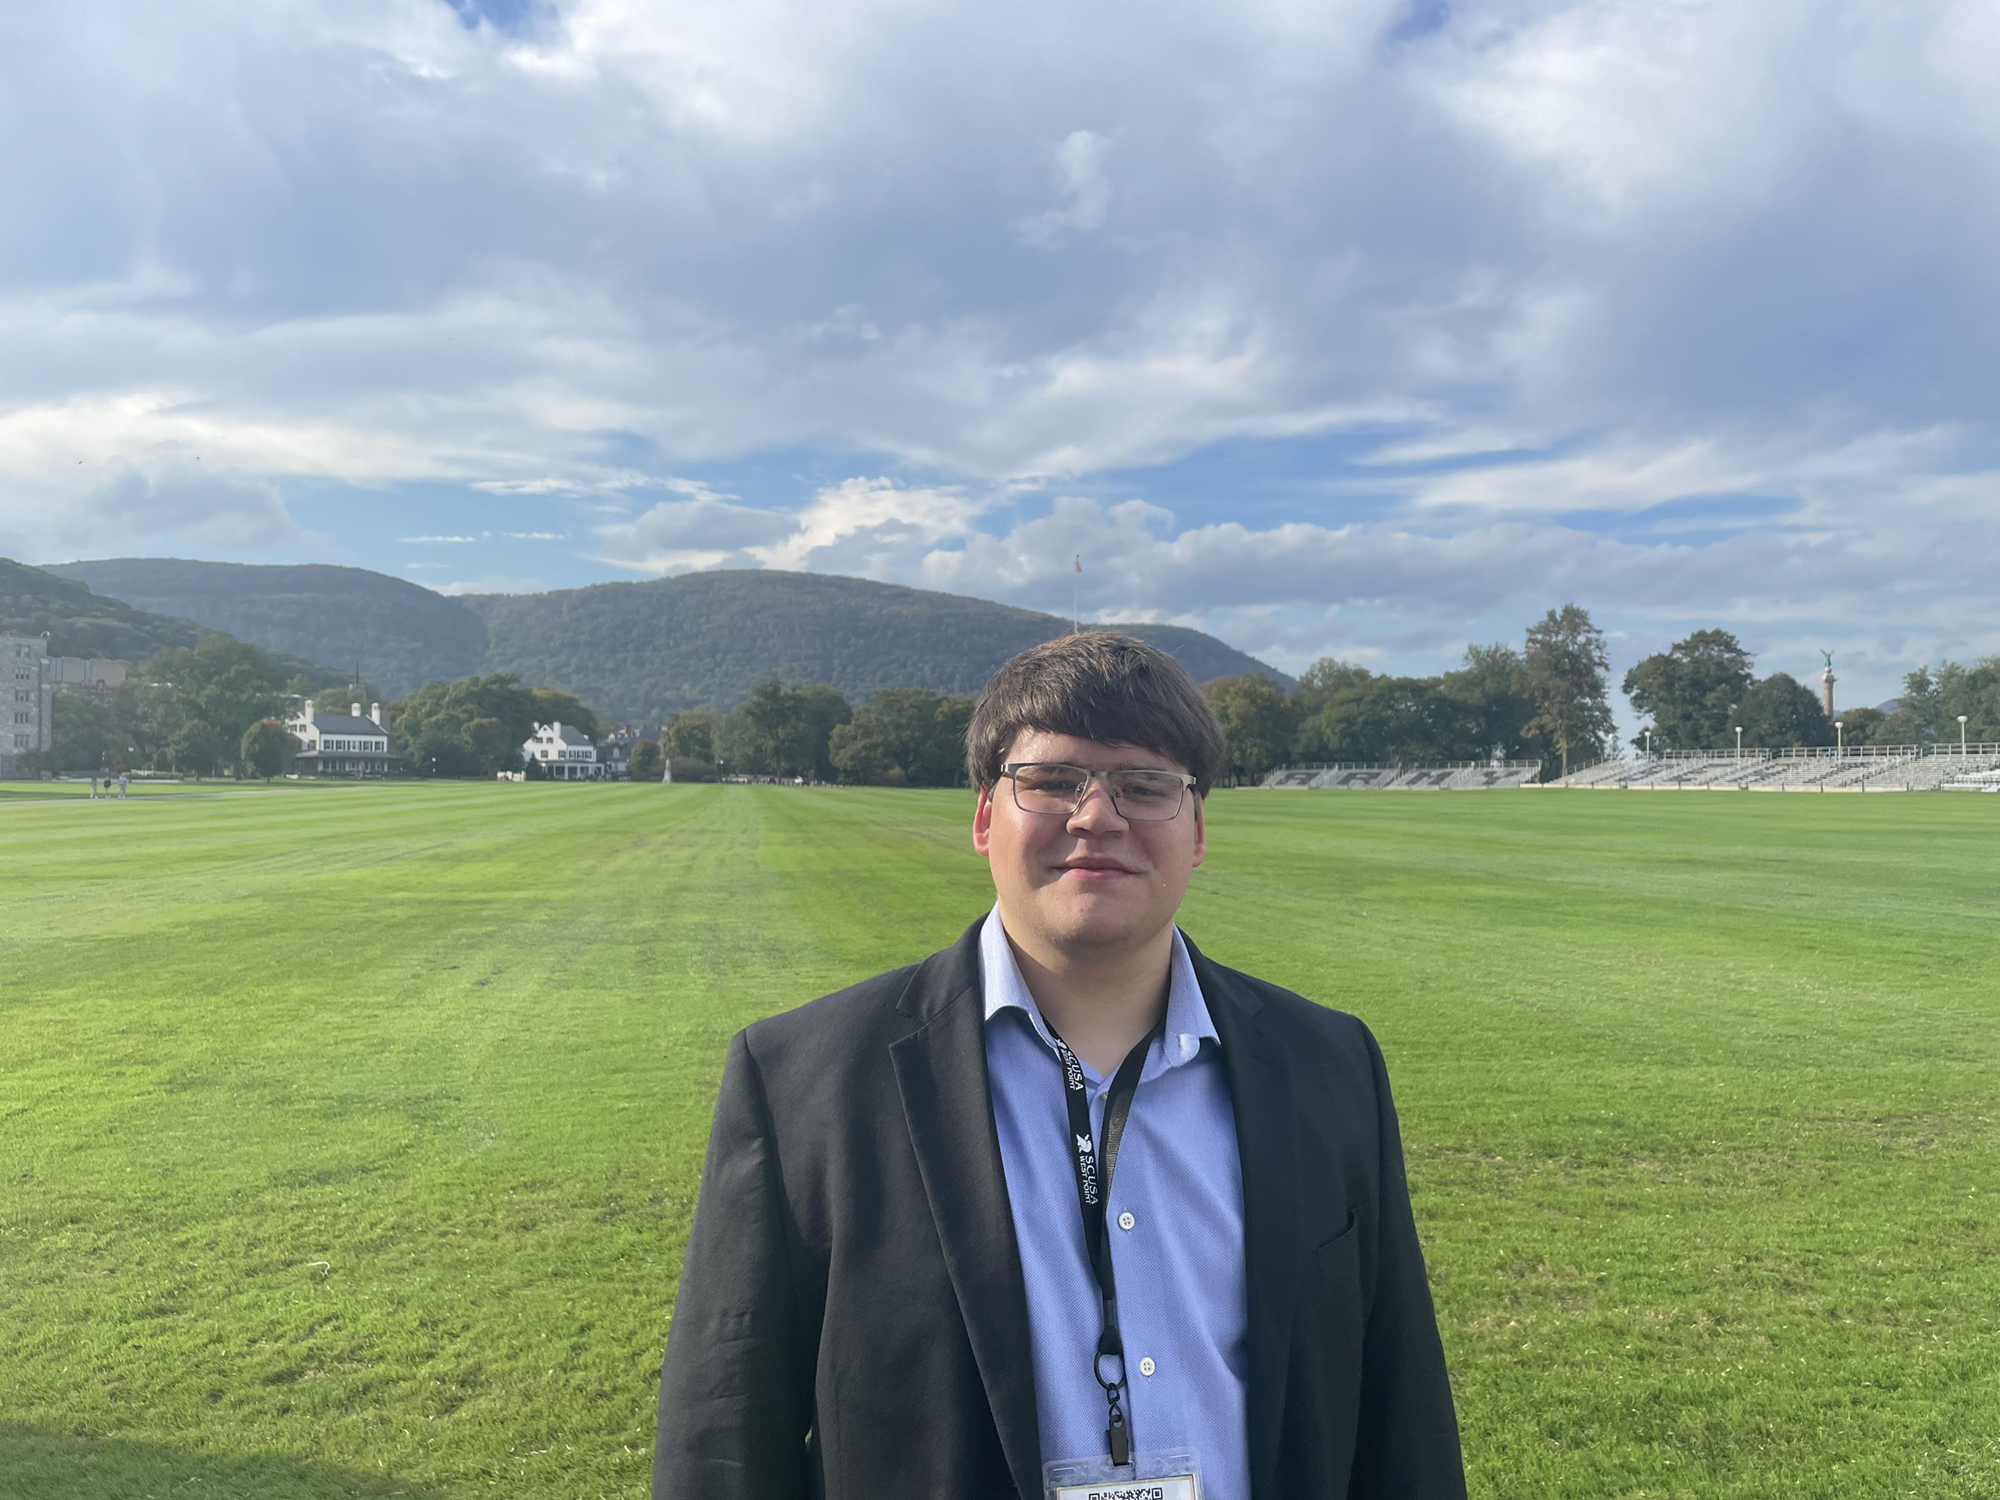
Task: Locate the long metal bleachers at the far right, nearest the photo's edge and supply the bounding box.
[1548,744,2000,792]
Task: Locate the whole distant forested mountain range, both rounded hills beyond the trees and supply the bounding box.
[52,558,1292,722]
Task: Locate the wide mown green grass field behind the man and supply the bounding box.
[0,786,2000,1500]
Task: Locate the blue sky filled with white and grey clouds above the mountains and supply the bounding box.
[0,0,2000,716]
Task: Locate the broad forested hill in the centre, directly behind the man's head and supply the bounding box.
[464,572,1278,720]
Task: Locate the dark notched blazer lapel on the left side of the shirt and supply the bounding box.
[890,924,1042,1498]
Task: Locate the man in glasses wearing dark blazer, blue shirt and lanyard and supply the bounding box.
[654,632,1464,1500]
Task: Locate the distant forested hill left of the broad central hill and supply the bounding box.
[46,558,486,696]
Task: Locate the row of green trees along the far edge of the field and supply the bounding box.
[42,604,2000,786]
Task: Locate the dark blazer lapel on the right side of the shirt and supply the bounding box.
[1188,942,1300,1496]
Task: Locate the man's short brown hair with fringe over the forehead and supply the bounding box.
[966,630,1224,792]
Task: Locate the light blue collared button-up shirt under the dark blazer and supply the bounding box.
[980,910,1250,1500]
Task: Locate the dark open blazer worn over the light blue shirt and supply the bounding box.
[652,924,1466,1500]
